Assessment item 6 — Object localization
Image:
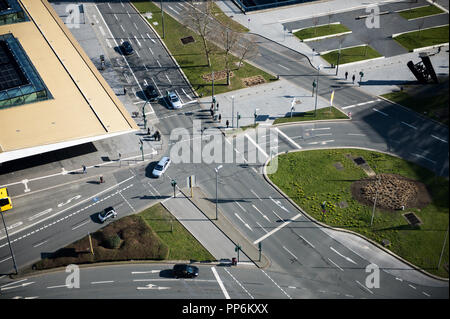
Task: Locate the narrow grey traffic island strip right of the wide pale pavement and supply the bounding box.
[183,187,270,268]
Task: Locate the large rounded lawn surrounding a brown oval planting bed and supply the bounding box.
[269,149,449,277]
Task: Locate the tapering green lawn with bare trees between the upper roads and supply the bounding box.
[133,2,275,96]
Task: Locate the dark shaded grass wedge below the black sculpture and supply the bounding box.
[382,89,449,126]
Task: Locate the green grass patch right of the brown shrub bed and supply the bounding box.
[139,204,215,261]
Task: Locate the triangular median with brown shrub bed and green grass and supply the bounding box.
[33,204,214,270]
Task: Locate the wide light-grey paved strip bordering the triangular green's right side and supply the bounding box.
[161,189,253,264]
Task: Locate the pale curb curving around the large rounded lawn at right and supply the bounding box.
[263,147,449,282]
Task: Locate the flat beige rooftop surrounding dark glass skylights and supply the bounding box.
[0,0,138,163]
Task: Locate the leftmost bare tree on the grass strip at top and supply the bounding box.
[184,0,214,67]
